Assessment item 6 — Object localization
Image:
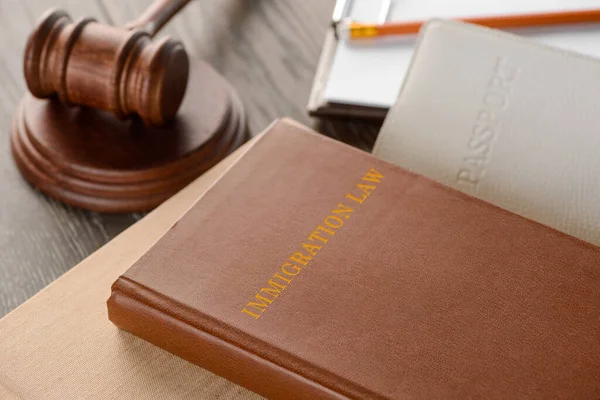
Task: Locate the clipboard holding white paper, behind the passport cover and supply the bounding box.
[307,0,600,120]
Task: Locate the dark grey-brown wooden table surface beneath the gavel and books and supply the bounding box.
[0,0,379,317]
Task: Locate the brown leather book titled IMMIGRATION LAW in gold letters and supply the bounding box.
[108,120,600,400]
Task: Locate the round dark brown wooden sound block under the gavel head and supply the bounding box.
[11,60,248,213]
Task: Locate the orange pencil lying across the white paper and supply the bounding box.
[346,9,600,40]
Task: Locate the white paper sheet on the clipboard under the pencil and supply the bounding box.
[324,0,600,108]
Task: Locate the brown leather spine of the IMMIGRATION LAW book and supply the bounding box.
[107,278,348,400]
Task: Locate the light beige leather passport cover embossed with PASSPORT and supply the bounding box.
[373,21,600,245]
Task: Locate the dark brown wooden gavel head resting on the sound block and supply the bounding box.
[24,11,189,125]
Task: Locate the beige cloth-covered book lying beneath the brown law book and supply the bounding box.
[0,138,260,400]
